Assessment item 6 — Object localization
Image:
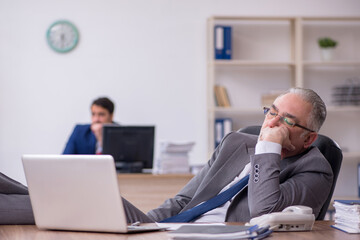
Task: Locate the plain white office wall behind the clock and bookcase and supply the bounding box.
[0,0,360,182]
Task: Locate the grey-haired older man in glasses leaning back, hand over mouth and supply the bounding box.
[124,88,333,222]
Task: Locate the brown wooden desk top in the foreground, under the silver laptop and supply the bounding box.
[0,221,360,240]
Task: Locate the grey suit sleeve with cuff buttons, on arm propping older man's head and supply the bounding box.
[248,149,333,217]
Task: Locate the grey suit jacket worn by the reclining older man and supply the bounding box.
[147,132,333,222]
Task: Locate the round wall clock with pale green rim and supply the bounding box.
[46,21,79,53]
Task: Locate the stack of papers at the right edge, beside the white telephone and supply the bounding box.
[333,200,360,233]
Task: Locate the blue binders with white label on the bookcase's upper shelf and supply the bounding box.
[214,25,232,59]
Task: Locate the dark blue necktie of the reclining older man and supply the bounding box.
[160,175,249,223]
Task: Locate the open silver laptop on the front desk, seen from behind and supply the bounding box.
[22,155,163,233]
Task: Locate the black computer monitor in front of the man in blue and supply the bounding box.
[102,125,155,173]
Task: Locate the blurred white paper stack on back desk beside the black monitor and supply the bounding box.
[156,142,195,174]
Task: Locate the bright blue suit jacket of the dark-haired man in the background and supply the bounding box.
[63,124,96,154]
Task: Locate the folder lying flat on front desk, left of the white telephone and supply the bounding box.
[169,224,272,239]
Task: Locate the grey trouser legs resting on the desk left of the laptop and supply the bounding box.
[0,173,35,224]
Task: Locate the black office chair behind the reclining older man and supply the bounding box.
[239,126,343,220]
